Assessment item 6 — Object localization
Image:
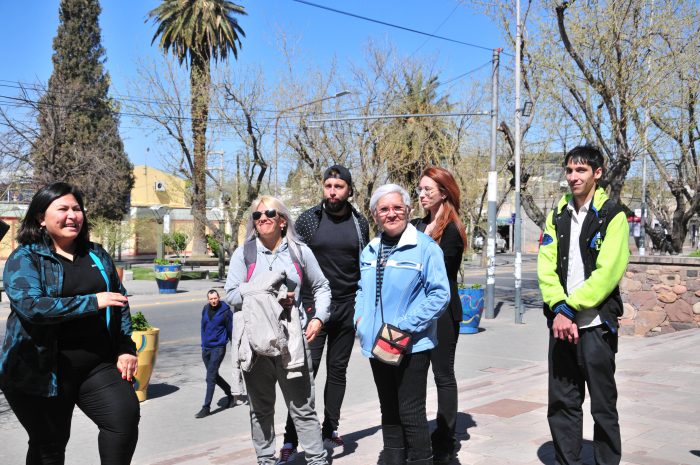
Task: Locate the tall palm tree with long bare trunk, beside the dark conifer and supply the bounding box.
[148,0,247,255]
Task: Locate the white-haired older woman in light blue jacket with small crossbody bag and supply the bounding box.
[354,184,450,465]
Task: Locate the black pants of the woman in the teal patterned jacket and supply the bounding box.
[4,363,140,465]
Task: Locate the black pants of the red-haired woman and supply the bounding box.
[430,309,459,452]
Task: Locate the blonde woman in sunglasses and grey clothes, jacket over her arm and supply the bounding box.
[224,196,331,465]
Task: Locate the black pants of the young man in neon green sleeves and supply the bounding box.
[547,326,622,465]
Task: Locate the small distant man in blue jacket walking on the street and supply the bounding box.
[194,289,234,418]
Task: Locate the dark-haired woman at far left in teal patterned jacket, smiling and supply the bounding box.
[0,182,140,465]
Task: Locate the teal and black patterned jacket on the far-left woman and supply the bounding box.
[0,243,136,397]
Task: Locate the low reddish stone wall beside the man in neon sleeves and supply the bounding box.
[620,256,700,336]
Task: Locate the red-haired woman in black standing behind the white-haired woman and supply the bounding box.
[412,166,467,465]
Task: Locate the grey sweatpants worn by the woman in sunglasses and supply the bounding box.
[243,350,328,465]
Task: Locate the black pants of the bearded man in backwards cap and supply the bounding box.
[284,299,355,447]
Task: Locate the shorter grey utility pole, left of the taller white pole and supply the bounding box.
[482,48,502,318]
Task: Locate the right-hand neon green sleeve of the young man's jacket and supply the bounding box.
[566,212,630,310]
